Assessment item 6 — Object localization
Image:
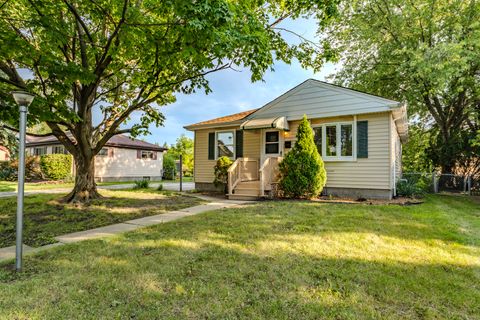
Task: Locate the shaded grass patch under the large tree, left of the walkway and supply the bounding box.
[0,189,201,248]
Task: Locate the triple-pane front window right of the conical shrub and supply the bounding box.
[313,122,354,161]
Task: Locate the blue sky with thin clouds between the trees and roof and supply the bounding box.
[132,19,337,145]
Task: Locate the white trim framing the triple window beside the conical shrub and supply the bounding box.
[312,120,357,162]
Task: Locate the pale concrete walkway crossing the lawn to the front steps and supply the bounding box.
[0,195,252,261]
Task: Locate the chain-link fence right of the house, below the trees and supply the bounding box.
[401,172,480,195]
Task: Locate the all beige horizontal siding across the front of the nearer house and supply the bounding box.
[195,112,391,190]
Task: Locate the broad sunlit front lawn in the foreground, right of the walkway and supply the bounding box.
[0,196,480,319]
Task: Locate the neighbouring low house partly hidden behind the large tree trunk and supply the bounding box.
[26,135,167,181]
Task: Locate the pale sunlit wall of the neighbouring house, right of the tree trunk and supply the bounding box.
[95,147,163,178]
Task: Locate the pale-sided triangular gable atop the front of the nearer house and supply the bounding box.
[247,79,400,120]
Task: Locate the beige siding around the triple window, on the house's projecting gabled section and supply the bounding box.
[285,112,391,189]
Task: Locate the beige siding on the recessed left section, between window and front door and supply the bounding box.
[194,127,261,183]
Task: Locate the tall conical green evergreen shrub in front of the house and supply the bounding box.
[279,115,327,198]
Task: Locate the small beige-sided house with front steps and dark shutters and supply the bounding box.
[185,79,408,199]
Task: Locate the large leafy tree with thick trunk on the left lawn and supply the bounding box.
[0,0,337,201]
